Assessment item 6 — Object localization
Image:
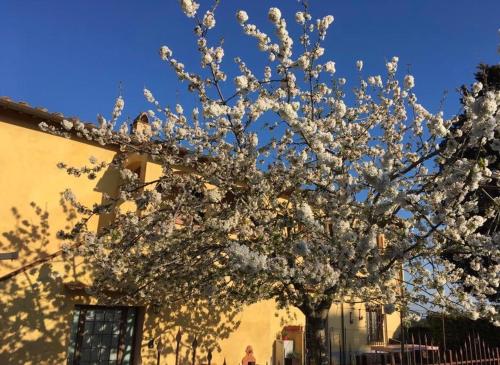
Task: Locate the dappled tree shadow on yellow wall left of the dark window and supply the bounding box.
[0,203,87,364]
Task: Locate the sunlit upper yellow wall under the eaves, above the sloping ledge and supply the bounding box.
[0,120,115,274]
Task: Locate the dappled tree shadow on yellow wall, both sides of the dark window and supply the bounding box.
[0,203,239,364]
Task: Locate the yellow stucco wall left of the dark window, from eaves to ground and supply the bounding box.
[0,115,114,364]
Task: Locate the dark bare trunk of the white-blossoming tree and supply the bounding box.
[304,305,330,365]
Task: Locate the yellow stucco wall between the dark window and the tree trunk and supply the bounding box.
[135,300,304,365]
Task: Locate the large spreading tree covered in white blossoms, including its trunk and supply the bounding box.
[45,0,500,364]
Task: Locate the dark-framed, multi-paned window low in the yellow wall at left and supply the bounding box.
[68,305,137,365]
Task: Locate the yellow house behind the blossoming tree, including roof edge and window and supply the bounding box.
[0,98,399,365]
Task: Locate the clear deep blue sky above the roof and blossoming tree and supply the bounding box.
[0,0,500,121]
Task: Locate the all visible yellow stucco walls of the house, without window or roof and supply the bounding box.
[0,113,397,365]
